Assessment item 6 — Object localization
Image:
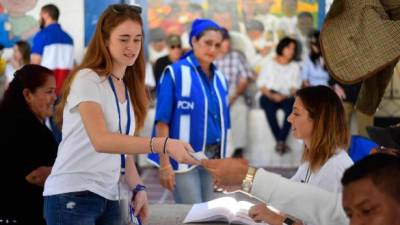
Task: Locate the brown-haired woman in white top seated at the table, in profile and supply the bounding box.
[249,86,353,225]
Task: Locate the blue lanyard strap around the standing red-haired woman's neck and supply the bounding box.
[108,77,131,174]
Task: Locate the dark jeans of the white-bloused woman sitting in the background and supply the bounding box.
[260,95,294,142]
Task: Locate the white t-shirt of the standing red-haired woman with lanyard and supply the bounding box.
[43,69,135,200]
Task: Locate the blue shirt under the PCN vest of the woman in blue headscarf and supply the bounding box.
[155,53,221,144]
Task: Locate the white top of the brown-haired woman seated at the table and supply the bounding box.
[291,149,353,193]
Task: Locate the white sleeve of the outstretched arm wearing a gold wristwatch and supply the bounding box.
[251,169,349,225]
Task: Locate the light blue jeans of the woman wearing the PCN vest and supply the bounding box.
[173,166,215,204]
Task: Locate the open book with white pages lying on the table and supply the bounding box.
[183,197,266,225]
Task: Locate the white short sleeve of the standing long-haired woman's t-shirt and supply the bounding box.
[67,69,102,110]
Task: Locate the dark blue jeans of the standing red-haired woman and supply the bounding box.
[44,191,122,225]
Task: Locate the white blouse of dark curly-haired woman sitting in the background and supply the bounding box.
[257,59,301,95]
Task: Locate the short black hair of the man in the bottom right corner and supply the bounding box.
[342,153,400,204]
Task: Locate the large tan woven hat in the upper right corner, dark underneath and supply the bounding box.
[320,0,400,115]
